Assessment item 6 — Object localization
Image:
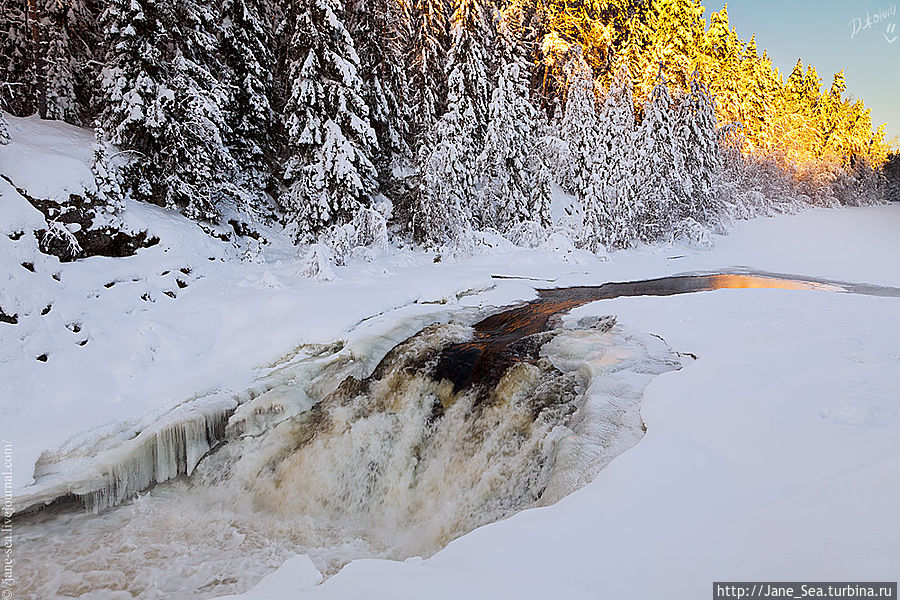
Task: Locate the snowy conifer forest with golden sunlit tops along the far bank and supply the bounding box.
[0,0,889,255]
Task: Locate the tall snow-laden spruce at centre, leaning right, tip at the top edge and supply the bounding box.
[413,0,490,245]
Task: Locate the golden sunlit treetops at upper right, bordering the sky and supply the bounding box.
[505,0,889,176]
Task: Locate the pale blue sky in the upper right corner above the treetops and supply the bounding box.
[704,0,900,143]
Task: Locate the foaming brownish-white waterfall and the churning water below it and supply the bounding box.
[17,320,680,599]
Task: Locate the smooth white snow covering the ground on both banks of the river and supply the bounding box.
[0,113,900,599]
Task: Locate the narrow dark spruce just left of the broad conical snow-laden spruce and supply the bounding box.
[221,0,275,199]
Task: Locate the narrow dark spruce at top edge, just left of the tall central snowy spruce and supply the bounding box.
[409,0,449,142]
